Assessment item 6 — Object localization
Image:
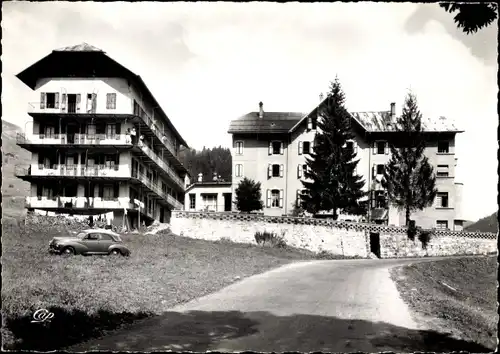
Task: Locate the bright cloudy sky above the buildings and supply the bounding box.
[1,1,498,220]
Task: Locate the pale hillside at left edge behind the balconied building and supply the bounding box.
[2,120,31,217]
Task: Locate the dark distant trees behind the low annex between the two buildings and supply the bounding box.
[179,146,232,183]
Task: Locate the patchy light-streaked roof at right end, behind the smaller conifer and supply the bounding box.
[351,111,462,132]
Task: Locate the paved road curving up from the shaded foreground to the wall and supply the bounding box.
[68,258,482,352]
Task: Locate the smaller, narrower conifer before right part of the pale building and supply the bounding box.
[384,93,437,225]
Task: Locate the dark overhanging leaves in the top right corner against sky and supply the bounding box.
[439,2,498,34]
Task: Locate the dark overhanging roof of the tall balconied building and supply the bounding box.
[16,43,189,147]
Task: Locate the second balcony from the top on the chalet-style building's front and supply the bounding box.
[16,133,132,146]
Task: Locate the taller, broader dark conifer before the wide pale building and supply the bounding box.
[301,78,366,219]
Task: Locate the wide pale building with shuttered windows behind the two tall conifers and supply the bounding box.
[228,97,463,230]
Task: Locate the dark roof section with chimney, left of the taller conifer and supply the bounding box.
[228,112,305,134]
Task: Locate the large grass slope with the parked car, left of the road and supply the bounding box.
[2,225,316,351]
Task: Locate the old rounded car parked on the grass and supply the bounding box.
[49,229,130,256]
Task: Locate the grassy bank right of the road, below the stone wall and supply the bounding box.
[391,256,498,351]
